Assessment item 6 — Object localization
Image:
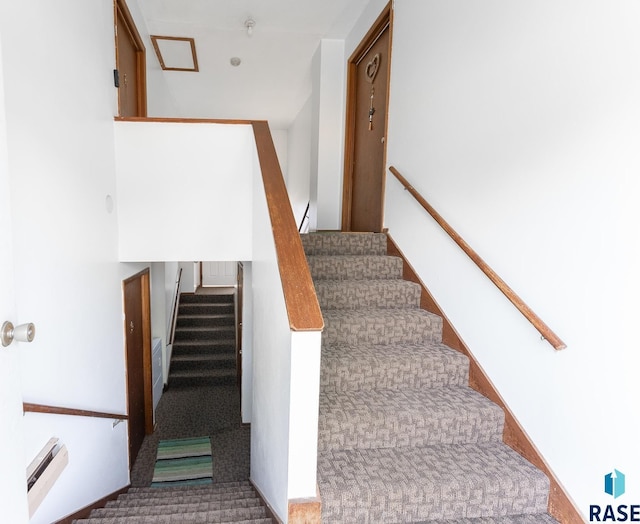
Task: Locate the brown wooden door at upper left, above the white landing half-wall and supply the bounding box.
[116,0,147,117]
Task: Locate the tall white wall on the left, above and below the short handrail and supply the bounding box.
[0,0,149,522]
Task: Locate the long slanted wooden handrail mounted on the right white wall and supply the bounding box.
[389,166,567,350]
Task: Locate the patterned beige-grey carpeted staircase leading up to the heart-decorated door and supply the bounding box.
[302,233,556,524]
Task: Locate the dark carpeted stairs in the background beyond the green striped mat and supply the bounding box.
[169,293,237,387]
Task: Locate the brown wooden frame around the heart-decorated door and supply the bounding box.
[342,2,393,231]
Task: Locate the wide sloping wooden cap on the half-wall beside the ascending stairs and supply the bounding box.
[253,121,324,331]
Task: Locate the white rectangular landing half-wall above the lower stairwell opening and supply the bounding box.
[115,122,254,262]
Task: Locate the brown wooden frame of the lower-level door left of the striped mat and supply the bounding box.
[122,267,153,467]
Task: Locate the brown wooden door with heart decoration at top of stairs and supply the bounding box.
[343,9,391,231]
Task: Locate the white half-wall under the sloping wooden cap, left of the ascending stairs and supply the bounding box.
[251,141,320,523]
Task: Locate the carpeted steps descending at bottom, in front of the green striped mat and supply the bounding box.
[74,481,273,524]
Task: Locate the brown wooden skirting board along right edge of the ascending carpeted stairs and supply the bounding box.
[387,235,584,524]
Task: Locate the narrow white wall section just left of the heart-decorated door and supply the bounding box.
[310,39,345,229]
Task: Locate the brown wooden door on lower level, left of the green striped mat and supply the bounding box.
[123,270,153,466]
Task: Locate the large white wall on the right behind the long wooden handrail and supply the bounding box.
[385,0,640,514]
